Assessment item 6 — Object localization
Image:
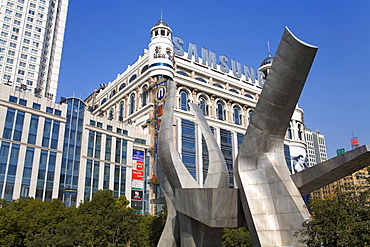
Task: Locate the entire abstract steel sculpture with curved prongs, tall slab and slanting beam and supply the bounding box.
[156,28,370,247]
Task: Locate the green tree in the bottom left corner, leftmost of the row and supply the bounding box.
[0,198,77,246]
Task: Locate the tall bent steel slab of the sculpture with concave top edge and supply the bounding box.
[235,28,317,246]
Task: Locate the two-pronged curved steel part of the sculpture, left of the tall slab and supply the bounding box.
[156,76,238,246]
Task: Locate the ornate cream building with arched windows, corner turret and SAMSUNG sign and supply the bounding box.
[84,21,312,212]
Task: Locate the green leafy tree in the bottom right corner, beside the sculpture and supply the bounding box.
[296,186,370,247]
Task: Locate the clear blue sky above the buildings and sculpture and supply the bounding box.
[58,0,370,158]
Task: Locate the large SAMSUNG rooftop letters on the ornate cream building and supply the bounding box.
[172,36,265,87]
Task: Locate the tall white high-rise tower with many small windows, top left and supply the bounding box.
[0,0,68,100]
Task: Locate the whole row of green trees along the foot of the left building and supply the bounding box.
[0,190,165,247]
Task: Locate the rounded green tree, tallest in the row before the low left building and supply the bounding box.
[76,190,140,246]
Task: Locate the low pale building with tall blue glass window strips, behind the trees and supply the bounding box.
[0,84,151,211]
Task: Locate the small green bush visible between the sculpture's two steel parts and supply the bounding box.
[221,227,253,247]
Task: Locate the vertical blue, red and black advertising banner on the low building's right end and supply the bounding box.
[131,149,145,213]
